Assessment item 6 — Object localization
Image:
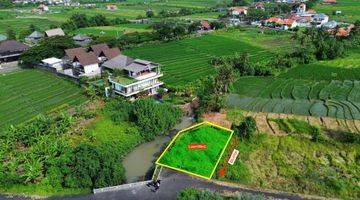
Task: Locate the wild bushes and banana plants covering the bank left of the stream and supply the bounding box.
[0,99,181,196]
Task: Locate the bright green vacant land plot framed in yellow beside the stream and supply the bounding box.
[156,122,233,179]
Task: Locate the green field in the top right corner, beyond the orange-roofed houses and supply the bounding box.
[315,0,360,22]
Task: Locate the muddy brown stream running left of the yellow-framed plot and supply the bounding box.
[123,116,194,183]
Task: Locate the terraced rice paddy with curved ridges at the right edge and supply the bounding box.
[228,77,360,119]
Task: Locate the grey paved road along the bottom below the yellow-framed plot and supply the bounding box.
[0,169,320,200]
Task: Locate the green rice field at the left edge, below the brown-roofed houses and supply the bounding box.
[0,70,87,129]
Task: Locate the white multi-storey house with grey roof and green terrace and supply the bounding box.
[102,55,163,97]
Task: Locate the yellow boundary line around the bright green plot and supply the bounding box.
[155,121,234,180]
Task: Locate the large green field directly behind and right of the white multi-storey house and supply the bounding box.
[124,28,292,86]
